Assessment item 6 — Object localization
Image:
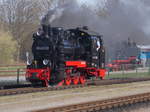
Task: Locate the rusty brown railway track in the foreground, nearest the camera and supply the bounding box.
[32,93,150,112]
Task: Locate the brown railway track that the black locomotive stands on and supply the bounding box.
[0,78,150,96]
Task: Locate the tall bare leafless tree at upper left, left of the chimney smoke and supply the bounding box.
[0,0,40,61]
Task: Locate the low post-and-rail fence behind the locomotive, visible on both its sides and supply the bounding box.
[0,64,150,85]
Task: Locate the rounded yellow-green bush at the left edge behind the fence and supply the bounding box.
[0,31,17,64]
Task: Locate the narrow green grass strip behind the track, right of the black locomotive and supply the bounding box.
[105,72,150,79]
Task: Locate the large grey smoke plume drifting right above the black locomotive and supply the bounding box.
[42,0,150,57]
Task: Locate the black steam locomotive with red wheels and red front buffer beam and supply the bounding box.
[25,25,105,86]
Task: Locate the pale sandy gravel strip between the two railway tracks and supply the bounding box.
[0,81,150,112]
